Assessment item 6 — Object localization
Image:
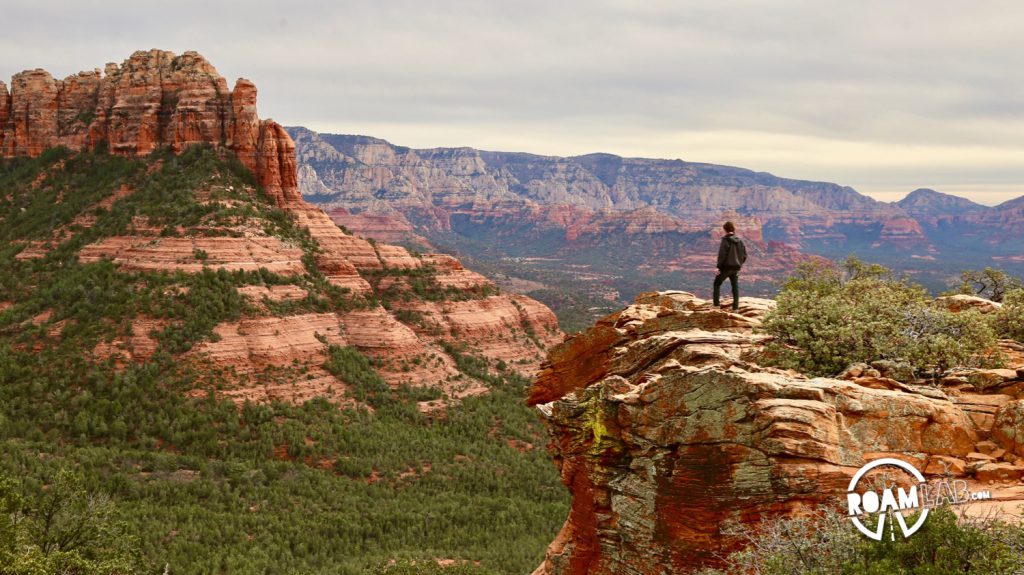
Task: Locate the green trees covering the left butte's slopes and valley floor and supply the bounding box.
[0,146,568,574]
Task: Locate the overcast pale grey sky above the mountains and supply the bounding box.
[0,0,1024,204]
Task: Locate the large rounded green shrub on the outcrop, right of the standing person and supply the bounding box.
[763,257,996,377]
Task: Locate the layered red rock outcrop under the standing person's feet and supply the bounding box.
[528,292,1024,575]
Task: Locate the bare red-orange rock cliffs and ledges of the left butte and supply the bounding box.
[0,50,561,408]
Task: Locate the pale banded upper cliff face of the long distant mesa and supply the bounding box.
[290,128,928,247]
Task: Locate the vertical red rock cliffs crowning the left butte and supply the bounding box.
[0,50,301,204]
